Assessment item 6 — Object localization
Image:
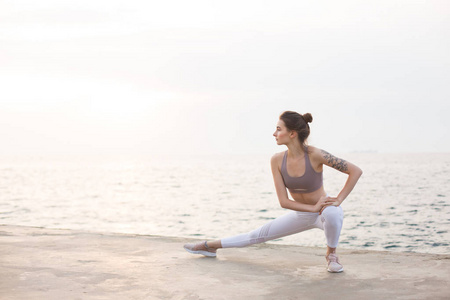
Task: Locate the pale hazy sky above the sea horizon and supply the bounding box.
[0,0,450,154]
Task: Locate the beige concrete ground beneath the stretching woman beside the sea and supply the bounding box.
[0,225,450,300]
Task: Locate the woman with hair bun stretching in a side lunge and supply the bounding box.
[184,111,362,272]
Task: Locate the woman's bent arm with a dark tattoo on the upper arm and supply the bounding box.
[319,150,363,205]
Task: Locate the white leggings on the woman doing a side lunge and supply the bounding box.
[221,206,344,248]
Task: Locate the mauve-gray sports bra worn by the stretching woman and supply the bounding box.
[281,149,323,194]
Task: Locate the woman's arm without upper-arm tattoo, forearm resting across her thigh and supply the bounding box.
[270,154,326,212]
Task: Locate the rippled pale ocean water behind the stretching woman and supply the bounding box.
[0,153,450,254]
